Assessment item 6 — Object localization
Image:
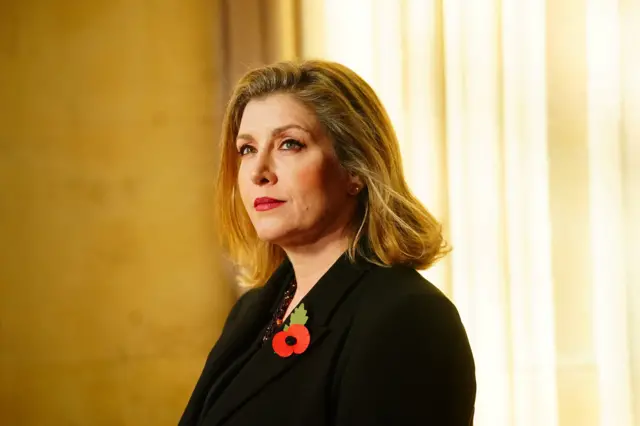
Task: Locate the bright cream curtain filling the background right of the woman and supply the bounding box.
[298,0,640,426]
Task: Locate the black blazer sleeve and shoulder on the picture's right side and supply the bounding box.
[334,267,476,426]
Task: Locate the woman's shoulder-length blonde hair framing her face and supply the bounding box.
[215,60,448,286]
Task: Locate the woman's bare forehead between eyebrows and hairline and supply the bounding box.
[239,94,318,133]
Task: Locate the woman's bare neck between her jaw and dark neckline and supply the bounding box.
[284,231,349,298]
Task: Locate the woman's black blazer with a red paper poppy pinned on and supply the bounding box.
[179,255,476,426]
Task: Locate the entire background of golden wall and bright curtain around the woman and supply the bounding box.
[0,0,640,426]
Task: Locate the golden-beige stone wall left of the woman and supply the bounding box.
[0,0,238,426]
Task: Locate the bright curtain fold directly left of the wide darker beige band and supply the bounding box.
[501,1,558,426]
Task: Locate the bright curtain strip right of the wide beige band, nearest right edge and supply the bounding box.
[587,0,633,426]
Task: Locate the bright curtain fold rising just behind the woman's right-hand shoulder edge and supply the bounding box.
[444,0,512,426]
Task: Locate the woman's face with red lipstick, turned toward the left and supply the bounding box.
[236,94,361,248]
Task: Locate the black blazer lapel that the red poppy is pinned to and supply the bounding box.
[203,254,370,425]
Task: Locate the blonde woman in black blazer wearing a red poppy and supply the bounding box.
[180,61,476,426]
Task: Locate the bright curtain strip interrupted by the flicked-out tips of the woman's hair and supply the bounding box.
[408,0,451,294]
